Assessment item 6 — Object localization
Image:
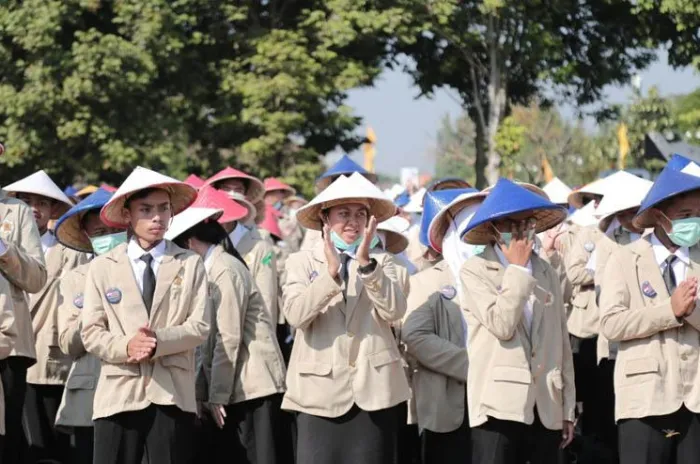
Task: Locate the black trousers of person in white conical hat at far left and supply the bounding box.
[22,383,72,464]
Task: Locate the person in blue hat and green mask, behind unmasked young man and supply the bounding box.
[55,189,126,464]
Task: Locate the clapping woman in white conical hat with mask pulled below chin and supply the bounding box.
[282,174,409,464]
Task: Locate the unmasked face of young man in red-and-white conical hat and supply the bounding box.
[124,190,172,243]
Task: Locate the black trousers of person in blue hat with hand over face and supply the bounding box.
[471,414,563,464]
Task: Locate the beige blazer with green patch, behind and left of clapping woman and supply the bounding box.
[236,228,278,330]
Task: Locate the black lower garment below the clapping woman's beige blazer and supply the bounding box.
[296,405,406,464]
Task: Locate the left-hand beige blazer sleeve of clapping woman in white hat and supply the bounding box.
[284,252,342,329]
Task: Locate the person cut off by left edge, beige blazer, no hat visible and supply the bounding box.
[0,190,47,464]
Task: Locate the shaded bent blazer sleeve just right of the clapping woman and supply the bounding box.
[401,296,469,382]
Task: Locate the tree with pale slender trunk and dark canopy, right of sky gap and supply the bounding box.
[394,0,674,187]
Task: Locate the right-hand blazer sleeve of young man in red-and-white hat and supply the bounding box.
[152,258,211,360]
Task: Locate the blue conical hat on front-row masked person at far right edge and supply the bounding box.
[634,166,700,229]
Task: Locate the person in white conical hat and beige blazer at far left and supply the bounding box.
[5,171,80,462]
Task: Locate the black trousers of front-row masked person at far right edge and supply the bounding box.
[618,406,700,464]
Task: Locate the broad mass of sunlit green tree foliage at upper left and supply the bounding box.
[0,0,406,192]
